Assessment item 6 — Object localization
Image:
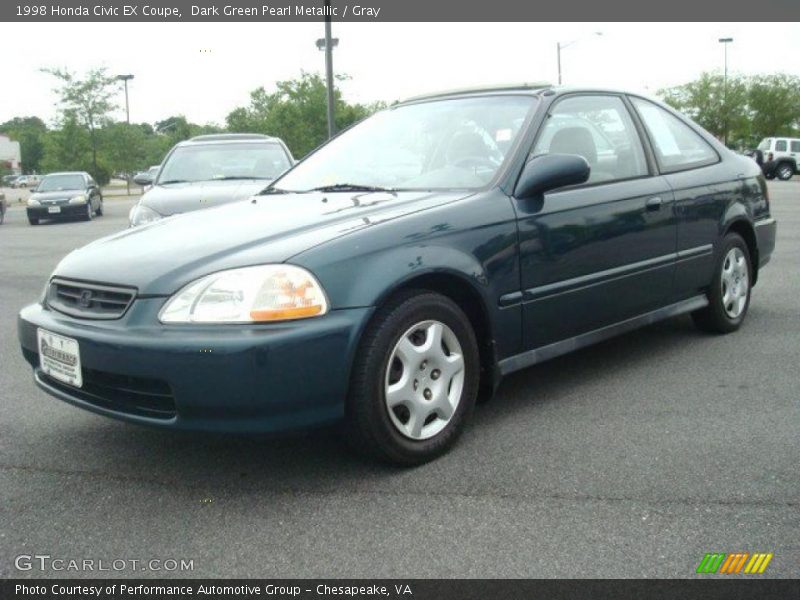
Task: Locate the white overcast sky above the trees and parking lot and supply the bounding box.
[0,23,800,124]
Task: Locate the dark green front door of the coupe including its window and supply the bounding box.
[515,94,676,350]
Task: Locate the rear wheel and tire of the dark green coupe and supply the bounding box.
[692,233,753,333]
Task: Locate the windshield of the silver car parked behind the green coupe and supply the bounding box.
[157,143,289,185]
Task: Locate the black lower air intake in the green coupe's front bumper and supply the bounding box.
[37,369,176,419]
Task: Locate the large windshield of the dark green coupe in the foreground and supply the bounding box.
[275,95,536,191]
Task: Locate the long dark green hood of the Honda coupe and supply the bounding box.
[54,192,466,296]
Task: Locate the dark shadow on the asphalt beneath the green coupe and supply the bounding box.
[21,317,704,495]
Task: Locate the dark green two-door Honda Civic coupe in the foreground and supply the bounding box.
[19,86,776,465]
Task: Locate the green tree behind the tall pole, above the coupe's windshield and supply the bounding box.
[225,72,383,158]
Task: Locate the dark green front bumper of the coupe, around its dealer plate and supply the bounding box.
[18,298,371,432]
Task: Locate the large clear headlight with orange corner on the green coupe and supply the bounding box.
[158,265,328,323]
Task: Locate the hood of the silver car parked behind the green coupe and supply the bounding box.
[141,179,270,216]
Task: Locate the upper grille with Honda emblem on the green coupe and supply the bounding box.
[47,279,136,319]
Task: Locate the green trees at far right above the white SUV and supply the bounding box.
[658,73,800,147]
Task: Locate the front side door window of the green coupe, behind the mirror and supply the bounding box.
[531,96,648,183]
